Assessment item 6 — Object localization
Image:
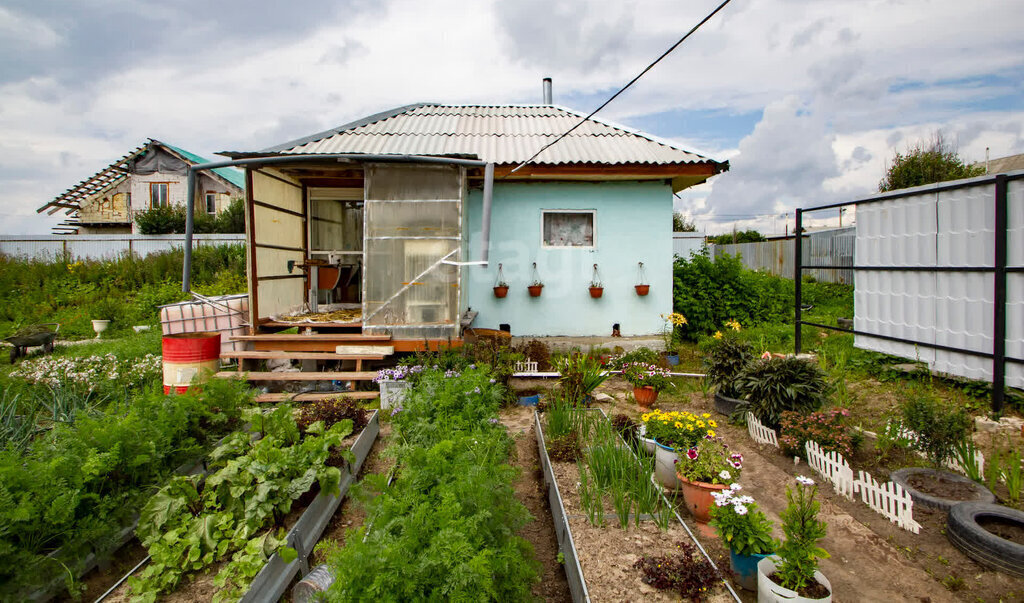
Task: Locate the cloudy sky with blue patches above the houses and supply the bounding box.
[0,0,1024,234]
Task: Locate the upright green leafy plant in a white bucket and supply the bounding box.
[758,475,831,603]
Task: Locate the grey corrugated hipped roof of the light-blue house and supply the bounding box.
[265,103,718,165]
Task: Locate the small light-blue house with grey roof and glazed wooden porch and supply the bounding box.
[222,99,728,351]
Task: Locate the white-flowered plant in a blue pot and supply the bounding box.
[710,483,778,591]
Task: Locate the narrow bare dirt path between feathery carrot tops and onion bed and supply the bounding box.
[501,406,572,602]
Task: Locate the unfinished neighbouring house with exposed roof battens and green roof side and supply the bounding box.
[37,138,245,234]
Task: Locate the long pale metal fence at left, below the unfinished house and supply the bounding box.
[0,234,245,260]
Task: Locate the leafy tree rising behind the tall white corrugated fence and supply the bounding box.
[879,132,985,192]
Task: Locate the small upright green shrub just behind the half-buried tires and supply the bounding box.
[900,388,972,467]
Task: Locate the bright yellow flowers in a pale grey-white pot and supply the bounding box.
[640,411,718,490]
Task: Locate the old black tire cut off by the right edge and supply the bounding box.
[946,503,1024,577]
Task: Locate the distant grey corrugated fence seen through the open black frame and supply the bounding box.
[708,227,857,285]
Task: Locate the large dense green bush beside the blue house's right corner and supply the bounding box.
[673,254,794,341]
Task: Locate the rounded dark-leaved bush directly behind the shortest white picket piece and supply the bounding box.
[736,356,831,429]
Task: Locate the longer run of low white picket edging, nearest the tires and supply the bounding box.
[804,441,921,533]
